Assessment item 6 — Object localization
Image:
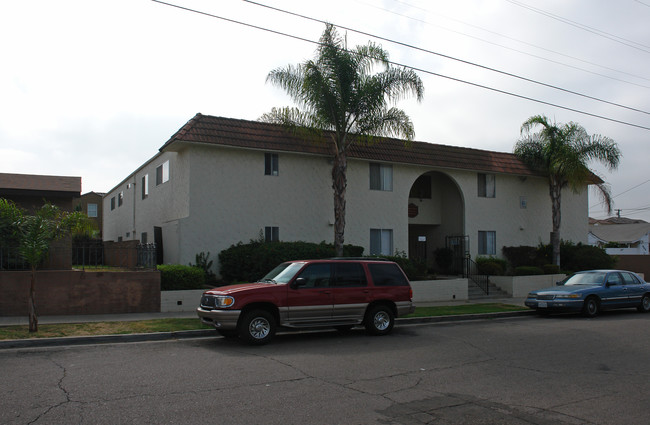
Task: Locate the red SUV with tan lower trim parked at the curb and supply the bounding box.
[197,259,415,344]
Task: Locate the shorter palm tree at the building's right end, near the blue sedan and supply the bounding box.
[514,115,621,266]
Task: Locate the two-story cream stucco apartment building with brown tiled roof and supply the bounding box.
[103,114,588,274]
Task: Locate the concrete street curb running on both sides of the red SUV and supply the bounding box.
[0,310,535,350]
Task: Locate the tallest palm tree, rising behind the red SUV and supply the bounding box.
[260,24,424,256]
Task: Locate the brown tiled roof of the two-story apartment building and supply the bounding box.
[160,113,539,176]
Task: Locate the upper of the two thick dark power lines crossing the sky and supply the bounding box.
[244,0,650,115]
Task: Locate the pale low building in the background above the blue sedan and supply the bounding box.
[588,220,650,255]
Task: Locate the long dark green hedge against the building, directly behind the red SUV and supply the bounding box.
[219,240,363,283]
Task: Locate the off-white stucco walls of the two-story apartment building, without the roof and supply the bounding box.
[104,139,588,274]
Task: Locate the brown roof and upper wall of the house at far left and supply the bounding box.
[0,173,81,213]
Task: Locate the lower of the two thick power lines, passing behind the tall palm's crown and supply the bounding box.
[151,0,650,130]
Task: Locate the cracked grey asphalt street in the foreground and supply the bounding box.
[0,310,650,425]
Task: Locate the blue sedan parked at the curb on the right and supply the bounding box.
[526,270,650,317]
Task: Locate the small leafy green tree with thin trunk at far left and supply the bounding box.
[6,202,93,332]
